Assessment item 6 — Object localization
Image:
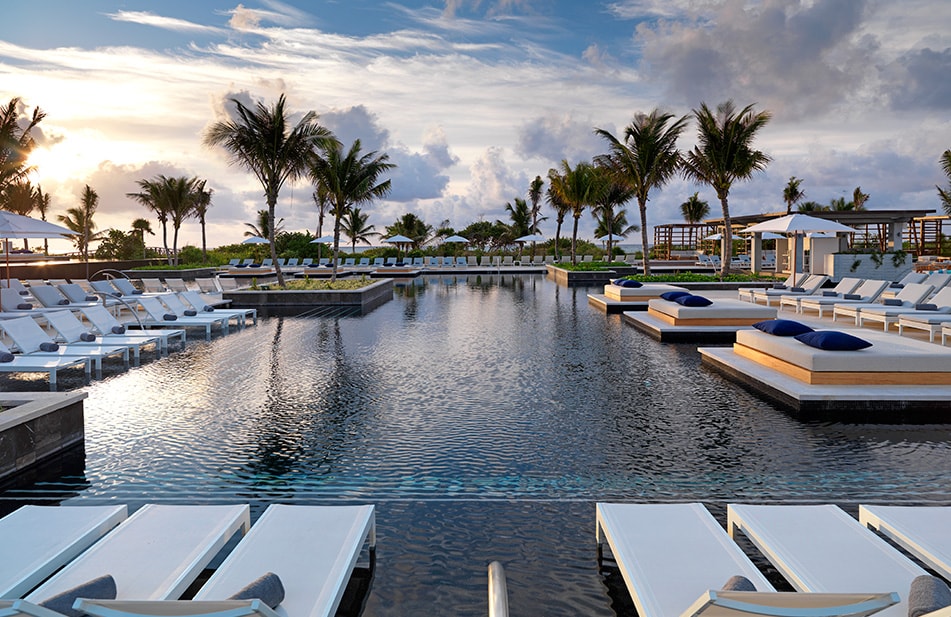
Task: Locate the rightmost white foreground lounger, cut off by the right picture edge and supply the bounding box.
[859,506,951,579]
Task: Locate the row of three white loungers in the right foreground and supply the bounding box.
[597,503,951,617]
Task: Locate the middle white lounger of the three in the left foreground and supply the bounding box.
[26,504,251,603]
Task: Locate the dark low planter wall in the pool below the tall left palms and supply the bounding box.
[222,279,393,317]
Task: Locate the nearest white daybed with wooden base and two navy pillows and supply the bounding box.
[733,329,951,386]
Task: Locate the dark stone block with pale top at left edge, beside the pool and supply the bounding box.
[0,392,87,480]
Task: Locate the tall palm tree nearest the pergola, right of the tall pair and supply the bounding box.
[683,101,772,276]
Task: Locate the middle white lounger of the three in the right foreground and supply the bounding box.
[727,504,926,617]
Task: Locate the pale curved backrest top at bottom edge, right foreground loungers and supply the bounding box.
[681,590,899,617]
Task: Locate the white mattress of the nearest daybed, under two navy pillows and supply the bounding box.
[736,330,951,373]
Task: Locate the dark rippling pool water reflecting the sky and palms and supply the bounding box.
[0,275,951,616]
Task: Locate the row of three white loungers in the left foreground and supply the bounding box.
[0,504,376,617]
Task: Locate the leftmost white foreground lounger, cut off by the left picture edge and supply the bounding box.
[0,505,127,598]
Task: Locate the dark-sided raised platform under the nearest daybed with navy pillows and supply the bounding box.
[698,347,951,423]
